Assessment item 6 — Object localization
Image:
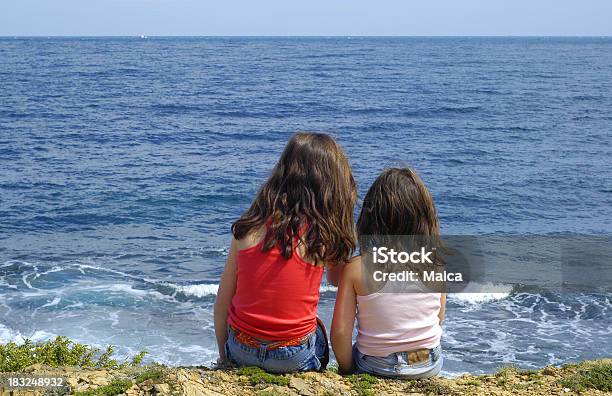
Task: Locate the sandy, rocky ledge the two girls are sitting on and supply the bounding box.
[0,359,612,396]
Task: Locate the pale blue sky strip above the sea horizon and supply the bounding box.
[0,0,612,36]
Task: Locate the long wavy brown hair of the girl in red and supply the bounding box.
[232,132,357,265]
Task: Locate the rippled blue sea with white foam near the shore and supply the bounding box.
[0,37,612,376]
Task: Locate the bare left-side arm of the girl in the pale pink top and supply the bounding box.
[331,262,359,374]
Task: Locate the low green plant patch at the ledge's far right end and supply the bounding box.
[557,360,612,392]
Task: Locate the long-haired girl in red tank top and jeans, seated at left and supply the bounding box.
[214,133,356,372]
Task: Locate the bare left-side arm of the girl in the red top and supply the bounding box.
[214,238,237,362]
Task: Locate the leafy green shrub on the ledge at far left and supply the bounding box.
[0,336,146,372]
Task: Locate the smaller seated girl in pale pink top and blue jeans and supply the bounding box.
[331,168,446,379]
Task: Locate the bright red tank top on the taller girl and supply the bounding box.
[228,235,323,341]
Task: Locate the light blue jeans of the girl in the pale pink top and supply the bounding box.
[353,345,443,379]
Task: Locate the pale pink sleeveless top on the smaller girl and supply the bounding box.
[357,286,442,357]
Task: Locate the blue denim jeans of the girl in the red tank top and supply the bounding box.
[225,326,329,374]
